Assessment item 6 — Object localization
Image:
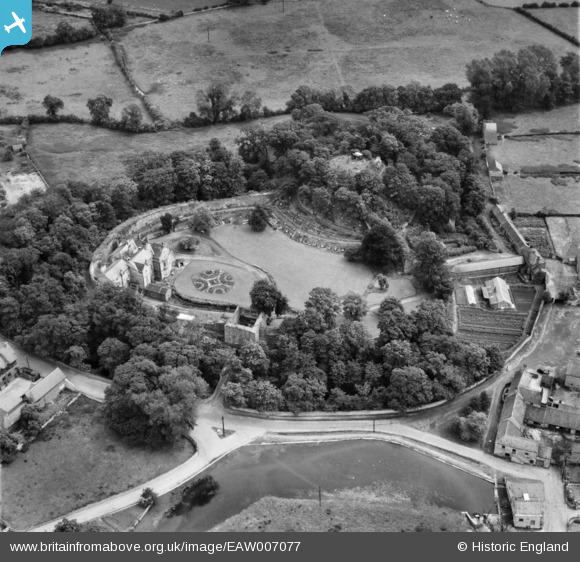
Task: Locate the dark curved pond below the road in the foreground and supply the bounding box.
[156,440,493,531]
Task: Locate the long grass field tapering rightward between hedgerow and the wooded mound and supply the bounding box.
[28,115,290,183]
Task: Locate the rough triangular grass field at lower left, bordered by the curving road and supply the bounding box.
[2,397,193,529]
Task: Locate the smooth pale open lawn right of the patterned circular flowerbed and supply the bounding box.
[211,225,373,308]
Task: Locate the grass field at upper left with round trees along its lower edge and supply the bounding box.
[0,41,145,118]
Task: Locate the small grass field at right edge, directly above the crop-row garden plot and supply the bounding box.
[494,174,580,214]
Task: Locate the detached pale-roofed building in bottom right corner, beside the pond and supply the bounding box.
[505,478,545,529]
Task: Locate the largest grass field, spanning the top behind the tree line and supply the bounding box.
[123,0,571,118]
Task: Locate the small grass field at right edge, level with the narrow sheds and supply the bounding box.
[491,135,580,172]
